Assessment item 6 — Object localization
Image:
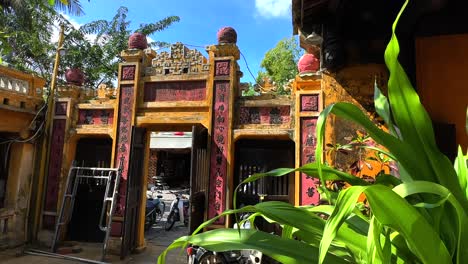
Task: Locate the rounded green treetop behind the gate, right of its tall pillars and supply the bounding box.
[257,37,301,89]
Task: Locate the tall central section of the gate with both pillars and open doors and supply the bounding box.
[112,36,245,253]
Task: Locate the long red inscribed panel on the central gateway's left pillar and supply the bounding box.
[115,86,135,219]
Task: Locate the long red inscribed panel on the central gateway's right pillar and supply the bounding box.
[208,81,229,224]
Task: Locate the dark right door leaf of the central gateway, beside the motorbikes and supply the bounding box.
[189,126,209,233]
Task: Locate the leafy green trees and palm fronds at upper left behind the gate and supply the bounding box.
[0,0,179,88]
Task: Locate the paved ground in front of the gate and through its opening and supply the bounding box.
[0,191,188,264]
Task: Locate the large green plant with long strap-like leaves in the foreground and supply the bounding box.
[158,0,468,264]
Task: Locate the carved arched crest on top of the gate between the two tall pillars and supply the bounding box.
[146,43,210,75]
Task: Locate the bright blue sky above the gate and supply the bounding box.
[71,0,292,82]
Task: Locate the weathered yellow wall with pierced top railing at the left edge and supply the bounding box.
[0,66,45,246]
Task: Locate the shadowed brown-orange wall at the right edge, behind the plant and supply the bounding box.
[416,34,468,149]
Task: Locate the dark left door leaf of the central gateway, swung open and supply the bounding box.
[120,127,146,259]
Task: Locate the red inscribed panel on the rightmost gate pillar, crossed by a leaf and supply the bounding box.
[300,117,320,205]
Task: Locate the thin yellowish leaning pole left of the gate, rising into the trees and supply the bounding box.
[32,24,65,238]
